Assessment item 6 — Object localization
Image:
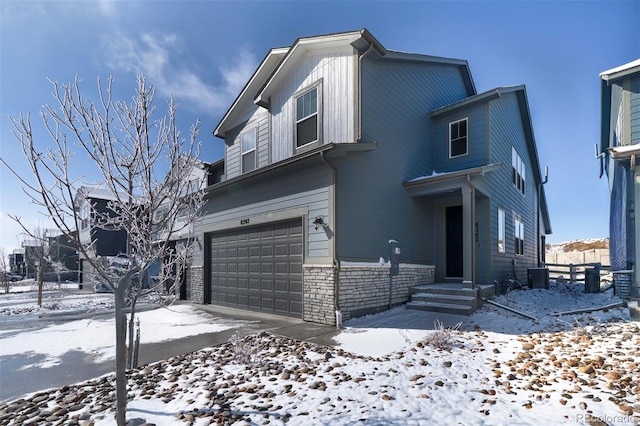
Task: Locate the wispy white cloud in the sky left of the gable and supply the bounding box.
[102,33,257,112]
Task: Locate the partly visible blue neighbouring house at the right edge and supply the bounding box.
[600,59,640,297]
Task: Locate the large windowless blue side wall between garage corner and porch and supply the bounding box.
[335,55,467,263]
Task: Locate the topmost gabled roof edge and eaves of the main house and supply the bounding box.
[213,28,476,138]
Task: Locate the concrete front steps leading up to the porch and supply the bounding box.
[407,283,495,315]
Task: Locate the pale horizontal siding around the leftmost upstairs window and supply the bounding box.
[225,105,269,179]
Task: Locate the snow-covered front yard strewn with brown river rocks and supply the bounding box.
[0,283,640,425]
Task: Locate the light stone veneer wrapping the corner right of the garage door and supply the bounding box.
[303,264,435,325]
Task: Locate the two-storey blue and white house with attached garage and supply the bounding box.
[189,30,551,324]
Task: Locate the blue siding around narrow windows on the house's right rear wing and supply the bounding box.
[486,93,537,283]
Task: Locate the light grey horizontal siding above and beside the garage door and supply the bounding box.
[194,165,331,265]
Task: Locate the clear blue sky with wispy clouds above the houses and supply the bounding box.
[0,0,640,251]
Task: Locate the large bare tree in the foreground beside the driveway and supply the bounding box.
[0,75,203,425]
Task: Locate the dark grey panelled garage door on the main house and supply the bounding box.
[209,219,303,317]
